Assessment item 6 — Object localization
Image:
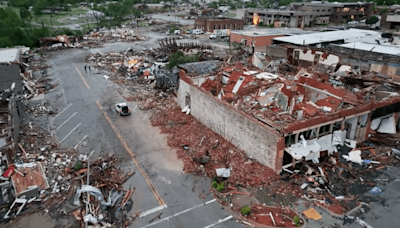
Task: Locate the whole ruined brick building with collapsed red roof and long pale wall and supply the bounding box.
[178,30,400,173]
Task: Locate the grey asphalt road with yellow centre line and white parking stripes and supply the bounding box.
[45,33,243,228]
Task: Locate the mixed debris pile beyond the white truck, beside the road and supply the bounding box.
[87,48,178,109]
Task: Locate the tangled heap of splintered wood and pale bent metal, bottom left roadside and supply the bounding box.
[69,154,138,227]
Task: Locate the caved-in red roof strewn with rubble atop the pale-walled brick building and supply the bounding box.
[182,52,400,134]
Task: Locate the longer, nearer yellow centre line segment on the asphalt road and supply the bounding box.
[96,101,165,205]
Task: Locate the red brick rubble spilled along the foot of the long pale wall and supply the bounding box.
[150,98,285,188]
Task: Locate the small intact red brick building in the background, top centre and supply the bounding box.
[194,18,244,32]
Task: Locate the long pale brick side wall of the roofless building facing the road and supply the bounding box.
[178,78,281,171]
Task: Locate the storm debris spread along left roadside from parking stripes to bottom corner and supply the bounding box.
[0,97,135,227]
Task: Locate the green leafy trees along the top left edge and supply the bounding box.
[0,0,172,48]
